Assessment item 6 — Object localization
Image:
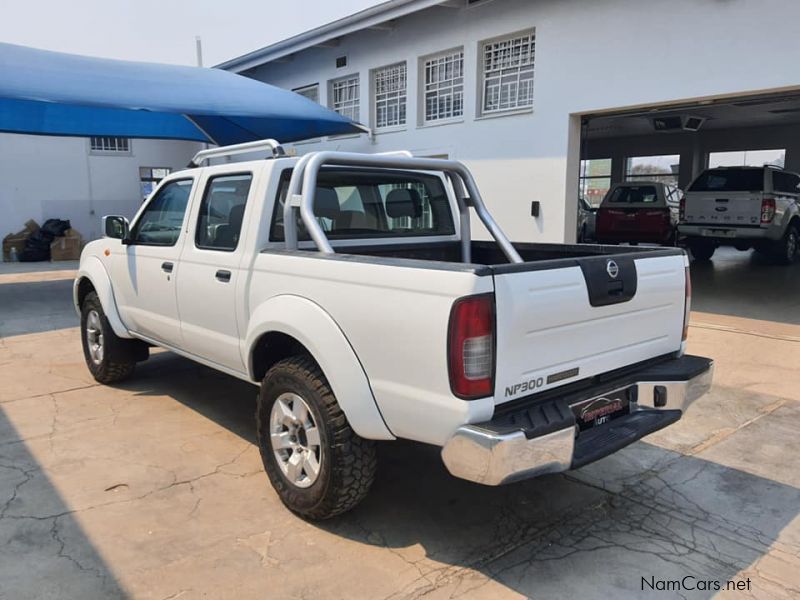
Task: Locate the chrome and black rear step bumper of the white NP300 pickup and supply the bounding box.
[442,356,714,485]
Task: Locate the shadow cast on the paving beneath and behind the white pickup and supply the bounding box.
[123,353,800,598]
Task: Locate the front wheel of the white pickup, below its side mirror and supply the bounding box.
[81,292,136,384]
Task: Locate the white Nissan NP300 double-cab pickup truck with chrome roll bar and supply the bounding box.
[74,141,713,519]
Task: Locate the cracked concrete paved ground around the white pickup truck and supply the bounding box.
[0,251,800,600]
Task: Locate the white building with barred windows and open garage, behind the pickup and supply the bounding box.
[220,0,800,241]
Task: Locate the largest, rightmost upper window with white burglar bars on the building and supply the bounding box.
[481,31,536,114]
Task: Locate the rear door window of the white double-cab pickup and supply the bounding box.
[195,173,253,252]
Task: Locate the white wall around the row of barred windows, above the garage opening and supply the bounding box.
[248,0,800,241]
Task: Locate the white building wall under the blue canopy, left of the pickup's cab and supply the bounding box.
[0,134,201,239]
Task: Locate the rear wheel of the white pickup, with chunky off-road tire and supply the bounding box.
[256,356,377,520]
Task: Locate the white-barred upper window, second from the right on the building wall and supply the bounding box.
[418,46,465,126]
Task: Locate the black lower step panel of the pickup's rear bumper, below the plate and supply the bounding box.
[570,409,681,469]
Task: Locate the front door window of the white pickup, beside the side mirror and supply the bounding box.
[131,179,192,246]
